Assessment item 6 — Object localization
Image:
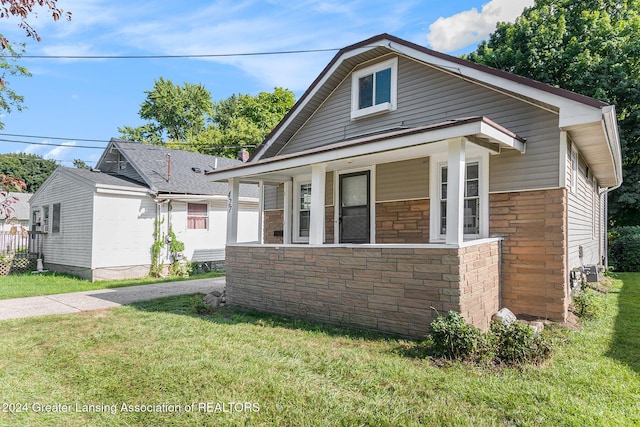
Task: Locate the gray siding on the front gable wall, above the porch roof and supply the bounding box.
[280,56,560,192]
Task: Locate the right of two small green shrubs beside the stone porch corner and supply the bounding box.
[489,322,551,365]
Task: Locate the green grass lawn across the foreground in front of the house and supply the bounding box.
[0,274,640,427]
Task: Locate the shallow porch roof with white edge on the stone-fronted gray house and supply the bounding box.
[207,117,525,182]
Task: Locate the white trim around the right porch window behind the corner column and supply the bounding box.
[429,153,489,243]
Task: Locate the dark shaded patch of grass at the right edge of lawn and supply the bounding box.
[607,273,640,372]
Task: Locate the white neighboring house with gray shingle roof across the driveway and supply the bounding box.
[30,139,258,280]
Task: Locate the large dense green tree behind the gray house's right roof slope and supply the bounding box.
[466,0,640,225]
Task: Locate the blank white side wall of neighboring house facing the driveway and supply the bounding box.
[91,193,156,268]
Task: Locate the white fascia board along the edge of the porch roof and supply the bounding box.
[210,121,524,182]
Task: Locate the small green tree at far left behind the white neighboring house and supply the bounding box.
[0,153,58,193]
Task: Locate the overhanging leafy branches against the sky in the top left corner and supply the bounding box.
[0,0,71,129]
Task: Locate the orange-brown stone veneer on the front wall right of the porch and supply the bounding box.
[489,189,570,322]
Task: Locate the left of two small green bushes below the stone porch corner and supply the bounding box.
[429,311,485,360]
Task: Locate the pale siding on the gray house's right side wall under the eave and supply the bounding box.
[567,150,604,269]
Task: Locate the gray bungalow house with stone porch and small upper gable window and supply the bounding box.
[209,34,622,337]
